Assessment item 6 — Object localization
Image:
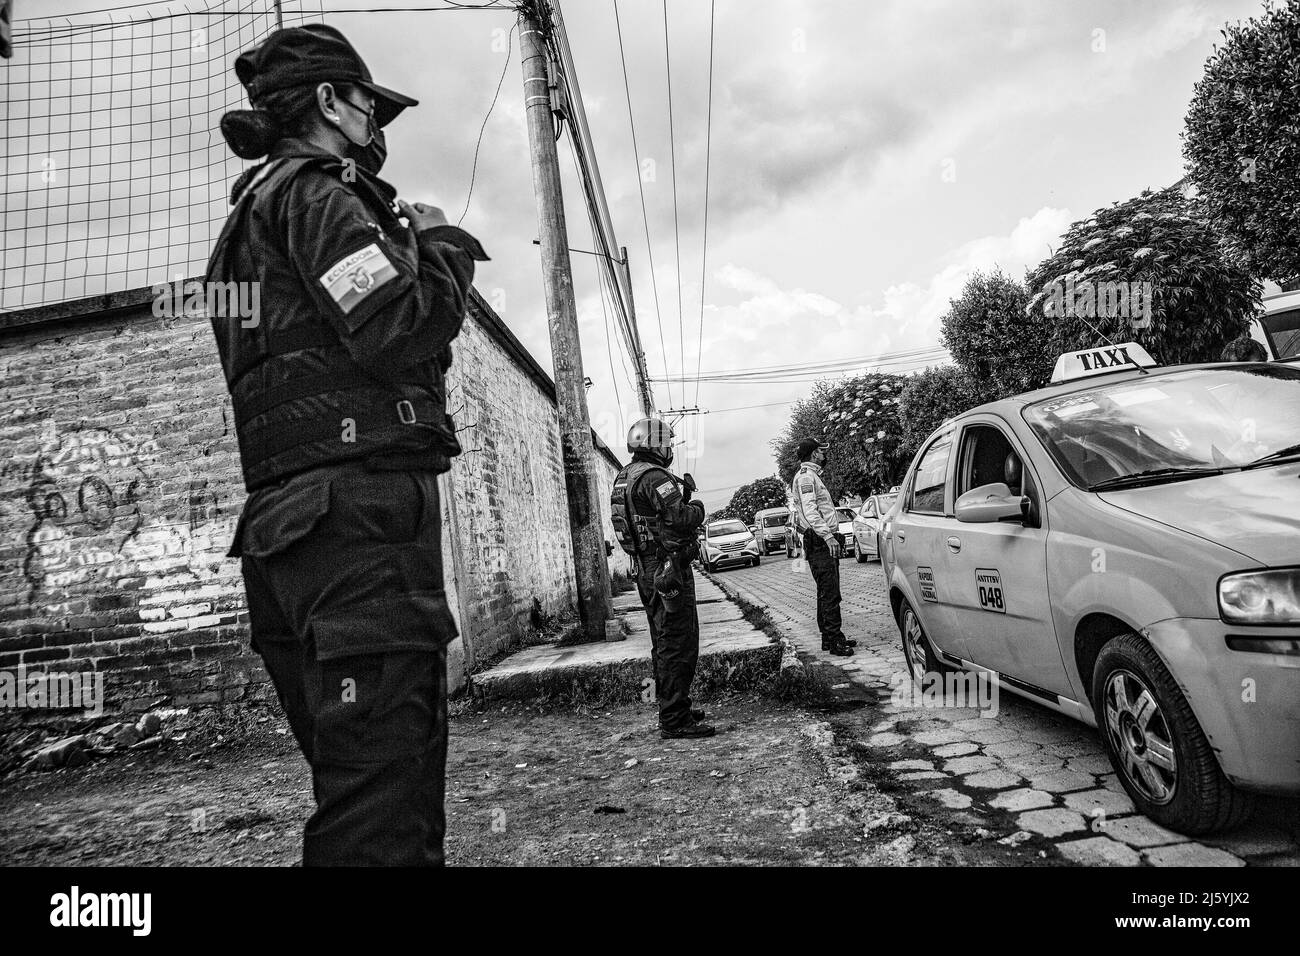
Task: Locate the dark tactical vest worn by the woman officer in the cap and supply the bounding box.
[207,156,460,492]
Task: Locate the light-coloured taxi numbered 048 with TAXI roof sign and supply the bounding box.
[881,343,1300,834]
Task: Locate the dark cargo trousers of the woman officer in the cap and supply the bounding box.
[231,464,456,866]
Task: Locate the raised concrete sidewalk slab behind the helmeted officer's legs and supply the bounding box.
[469,575,781,704]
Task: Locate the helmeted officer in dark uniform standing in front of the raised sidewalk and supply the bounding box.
[610,419,715,740]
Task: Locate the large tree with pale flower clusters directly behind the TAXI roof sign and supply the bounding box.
[1027,187,1260,366]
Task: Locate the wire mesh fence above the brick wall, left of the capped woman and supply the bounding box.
[0,0,322,310]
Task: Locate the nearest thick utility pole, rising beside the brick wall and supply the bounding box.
[519,0,611,639]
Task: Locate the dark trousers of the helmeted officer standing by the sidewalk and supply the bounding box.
[637,558,699,730]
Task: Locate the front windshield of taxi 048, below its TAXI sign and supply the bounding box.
[1023,363,1300,490]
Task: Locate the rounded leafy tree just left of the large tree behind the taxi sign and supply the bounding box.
[940,271,1056,405]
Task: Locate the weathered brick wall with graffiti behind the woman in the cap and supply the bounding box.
[0,290,625,710]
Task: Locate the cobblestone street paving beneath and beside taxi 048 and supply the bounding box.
[712,554,1300,866]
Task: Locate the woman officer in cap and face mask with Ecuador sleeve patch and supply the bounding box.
[208,23,486,865]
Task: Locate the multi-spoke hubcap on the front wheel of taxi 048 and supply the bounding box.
[1104,670,1178,804]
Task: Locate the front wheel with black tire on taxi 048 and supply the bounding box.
[1092,632,1255,836]
